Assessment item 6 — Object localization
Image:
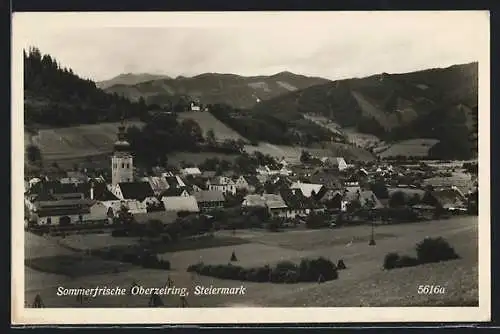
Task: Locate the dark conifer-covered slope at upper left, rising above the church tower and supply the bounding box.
[24,48,155,127]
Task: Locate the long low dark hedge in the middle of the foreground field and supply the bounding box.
[187,257,338,283]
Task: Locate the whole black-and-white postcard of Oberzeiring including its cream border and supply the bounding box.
[12,11,490,323]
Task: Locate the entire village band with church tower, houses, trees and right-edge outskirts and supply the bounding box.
[25,125,478,237]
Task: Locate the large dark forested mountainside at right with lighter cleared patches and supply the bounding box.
[253,63,478,159]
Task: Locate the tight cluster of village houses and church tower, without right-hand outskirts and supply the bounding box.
[24,126,477,225]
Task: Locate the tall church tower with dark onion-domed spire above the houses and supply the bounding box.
[111,122,134,186]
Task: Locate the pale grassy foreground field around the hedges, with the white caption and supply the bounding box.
[25,217,478,307]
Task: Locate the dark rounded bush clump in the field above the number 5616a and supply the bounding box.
[384,237,459,270]
